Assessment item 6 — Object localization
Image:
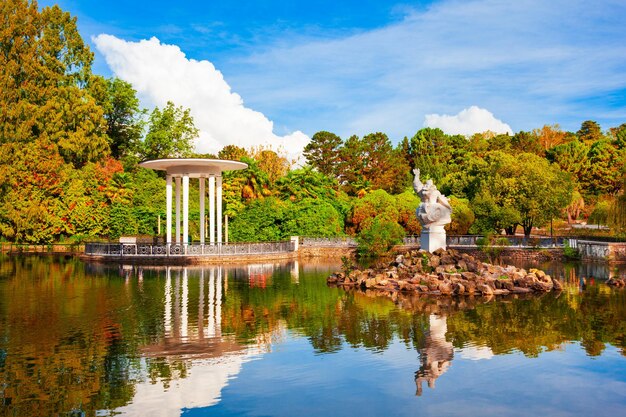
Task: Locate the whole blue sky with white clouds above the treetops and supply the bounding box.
[39,0,626,155]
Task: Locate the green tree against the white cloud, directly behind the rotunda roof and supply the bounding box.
[141,101,198,160]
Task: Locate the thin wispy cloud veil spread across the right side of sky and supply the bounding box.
[223,0,626,140]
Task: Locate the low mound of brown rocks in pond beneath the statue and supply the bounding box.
[327,249,563,296]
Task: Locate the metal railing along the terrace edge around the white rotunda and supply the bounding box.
[85,241,295,257]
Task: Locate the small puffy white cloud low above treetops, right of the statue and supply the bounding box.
[424,106,513,136]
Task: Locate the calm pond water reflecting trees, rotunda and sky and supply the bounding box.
[0,257,626,417]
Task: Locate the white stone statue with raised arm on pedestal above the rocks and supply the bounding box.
[413,169,452,252]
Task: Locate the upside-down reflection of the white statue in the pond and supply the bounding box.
[415,314,454,397]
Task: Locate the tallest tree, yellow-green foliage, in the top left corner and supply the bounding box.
[0,0,108,168]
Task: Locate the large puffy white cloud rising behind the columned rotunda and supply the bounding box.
[93,34,309,157]
